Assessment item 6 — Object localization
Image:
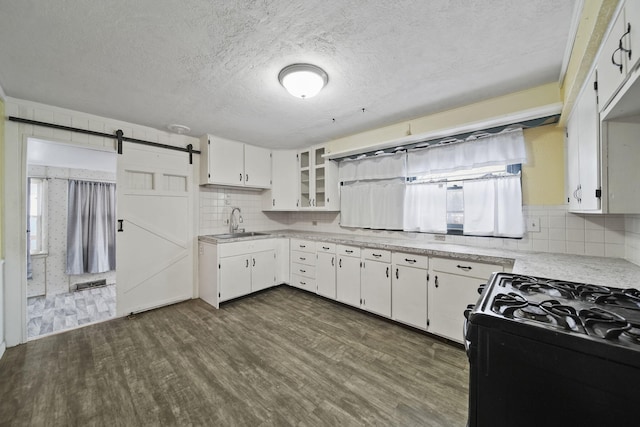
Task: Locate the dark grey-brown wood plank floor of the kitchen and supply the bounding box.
[0,286,468,427]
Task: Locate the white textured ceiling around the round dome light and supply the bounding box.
[0,0,576,148]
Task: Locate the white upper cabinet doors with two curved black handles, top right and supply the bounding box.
[597,0,640,109]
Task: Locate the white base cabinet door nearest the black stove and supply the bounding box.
[427,271,486,343]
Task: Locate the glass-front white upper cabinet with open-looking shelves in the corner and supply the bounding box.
[297,147,340,211]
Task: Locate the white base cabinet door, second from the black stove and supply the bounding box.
[391,265,427,329]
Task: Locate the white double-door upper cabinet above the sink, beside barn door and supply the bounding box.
[200,135,271,188]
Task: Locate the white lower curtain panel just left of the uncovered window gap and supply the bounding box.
[403,183,447,233]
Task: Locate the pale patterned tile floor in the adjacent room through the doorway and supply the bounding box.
[27,284,116,338]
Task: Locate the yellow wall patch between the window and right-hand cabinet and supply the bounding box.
[522,125,565,205]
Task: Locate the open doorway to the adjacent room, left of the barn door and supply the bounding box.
[26,138,117,339]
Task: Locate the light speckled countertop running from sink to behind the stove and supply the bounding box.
[199,230,640,288]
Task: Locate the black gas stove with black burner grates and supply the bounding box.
[465,273,640,427]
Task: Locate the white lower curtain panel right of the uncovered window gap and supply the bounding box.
[463,176,524,237]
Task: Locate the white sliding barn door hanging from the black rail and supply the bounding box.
[116,143,194,316]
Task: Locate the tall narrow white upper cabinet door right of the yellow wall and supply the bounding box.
[567,72,602,212]
